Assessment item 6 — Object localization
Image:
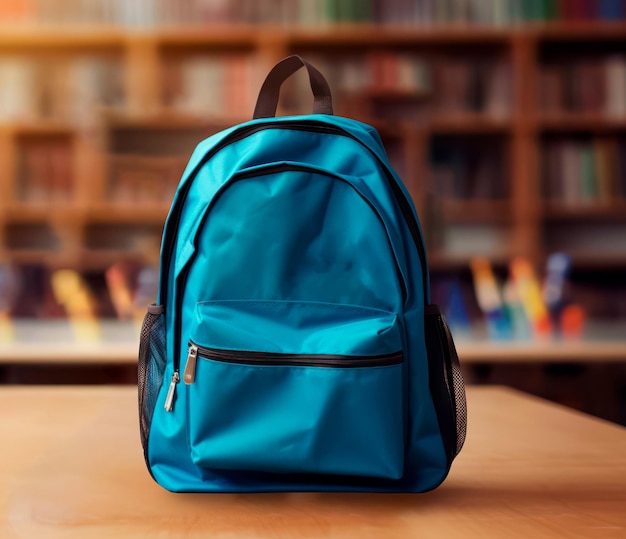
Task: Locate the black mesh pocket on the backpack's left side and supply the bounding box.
[137,305,167,464]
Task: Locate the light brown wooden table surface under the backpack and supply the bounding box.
[0,386,626,539]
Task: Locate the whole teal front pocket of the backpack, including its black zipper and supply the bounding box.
[183,301,404,479]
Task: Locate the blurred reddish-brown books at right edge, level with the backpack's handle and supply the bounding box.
[540,54,626,117]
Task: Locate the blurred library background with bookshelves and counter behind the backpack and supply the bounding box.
[0,0,626,424]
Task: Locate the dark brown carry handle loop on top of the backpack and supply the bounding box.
[253,55,333,120]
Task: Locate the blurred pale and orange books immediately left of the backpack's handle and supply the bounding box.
[162,54,262,119]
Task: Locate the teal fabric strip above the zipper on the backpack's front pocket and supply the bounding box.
[189,300,402,358]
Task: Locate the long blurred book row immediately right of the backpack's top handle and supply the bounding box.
[300,51,512,117]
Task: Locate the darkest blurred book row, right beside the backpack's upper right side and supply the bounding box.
[429,137,509,200]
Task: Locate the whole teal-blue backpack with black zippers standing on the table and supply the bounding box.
[139,56,466,492]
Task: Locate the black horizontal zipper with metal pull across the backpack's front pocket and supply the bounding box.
[183,341,402,385]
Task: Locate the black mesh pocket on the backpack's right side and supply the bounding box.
[424,305,467,464]
